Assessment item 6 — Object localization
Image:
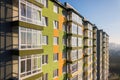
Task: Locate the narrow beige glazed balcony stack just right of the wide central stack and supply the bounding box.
[83,21,94,80]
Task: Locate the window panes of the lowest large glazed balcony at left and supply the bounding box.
[20,54,42,77]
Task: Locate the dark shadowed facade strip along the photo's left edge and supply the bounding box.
[0,0,18,80]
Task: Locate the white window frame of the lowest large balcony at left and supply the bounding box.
[19,54,42,79]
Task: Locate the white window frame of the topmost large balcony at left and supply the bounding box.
[19,0,42,25]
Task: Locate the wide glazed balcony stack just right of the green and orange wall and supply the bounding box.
[65,3,83,80]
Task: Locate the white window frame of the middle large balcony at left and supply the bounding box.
[19,26,42,50]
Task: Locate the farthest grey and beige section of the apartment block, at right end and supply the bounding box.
[97,30,109,80]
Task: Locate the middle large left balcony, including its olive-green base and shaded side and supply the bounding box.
[12,26,43,55]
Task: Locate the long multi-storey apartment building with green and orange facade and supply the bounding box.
[0,0,109,80]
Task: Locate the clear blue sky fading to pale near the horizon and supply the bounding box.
[59,0,120,44]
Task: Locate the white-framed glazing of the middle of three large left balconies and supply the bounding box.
[19,27,42,49]
